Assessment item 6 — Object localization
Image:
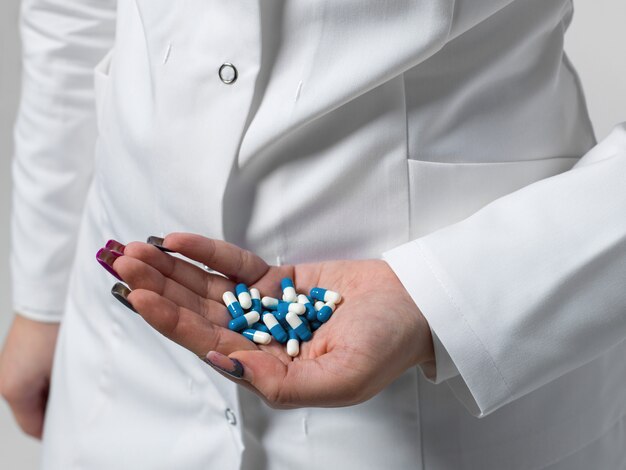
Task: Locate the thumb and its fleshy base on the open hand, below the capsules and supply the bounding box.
[222,350,369,408]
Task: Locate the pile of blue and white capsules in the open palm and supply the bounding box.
[222,277,341,357]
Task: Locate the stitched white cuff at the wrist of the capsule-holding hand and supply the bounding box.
[383,239,512,417]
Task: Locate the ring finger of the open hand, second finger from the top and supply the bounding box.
[124,242,234,300]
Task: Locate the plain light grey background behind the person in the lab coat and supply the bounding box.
[0,0,626,470]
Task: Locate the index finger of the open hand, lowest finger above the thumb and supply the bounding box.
[128,289,256,357]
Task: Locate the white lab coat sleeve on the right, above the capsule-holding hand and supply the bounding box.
[384,123,626,416]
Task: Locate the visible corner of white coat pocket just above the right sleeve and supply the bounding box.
[407,157,579,239]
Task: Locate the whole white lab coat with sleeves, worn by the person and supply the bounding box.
[12,0,626,470]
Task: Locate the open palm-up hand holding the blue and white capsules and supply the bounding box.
[101,233,434,408]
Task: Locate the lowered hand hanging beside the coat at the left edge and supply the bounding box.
[0,314,59,439]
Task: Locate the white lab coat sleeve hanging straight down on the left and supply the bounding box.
[10,0,116,321]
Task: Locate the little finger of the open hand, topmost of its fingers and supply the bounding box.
[158,233,269,284]
